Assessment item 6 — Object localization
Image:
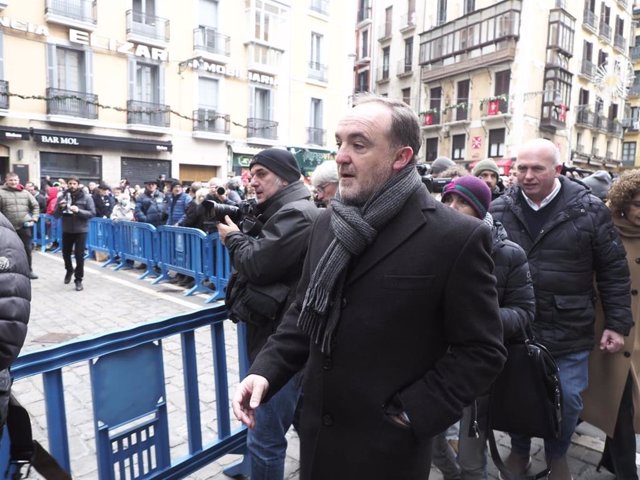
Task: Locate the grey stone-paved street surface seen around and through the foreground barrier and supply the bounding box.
[14,252,636,480]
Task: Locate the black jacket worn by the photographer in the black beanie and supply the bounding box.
[225,182,320,361]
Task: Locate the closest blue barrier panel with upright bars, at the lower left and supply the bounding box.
[0,306,247,480]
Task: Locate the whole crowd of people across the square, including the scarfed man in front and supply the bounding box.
[0,95,640,480]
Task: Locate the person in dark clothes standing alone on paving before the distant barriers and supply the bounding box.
[53,176,96,291]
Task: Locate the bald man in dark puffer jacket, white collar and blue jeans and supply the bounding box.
[490,138,633,480]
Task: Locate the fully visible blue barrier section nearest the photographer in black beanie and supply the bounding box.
[151,225,213,295]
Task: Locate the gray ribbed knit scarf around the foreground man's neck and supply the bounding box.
[298,164,422,355]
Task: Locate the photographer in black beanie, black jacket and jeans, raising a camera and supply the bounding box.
[216,148,319,480]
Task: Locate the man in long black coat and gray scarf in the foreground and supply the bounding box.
[233,96,505,480]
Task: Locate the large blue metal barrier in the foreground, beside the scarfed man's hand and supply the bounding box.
[0,307,252,480]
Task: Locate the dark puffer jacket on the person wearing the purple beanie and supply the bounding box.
[485,215,536,343]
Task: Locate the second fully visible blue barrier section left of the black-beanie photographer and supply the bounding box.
[112,220,160,279]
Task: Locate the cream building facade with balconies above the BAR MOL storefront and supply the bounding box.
[0,0,355,188]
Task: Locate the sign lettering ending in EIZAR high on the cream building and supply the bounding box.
[0,17,169,62]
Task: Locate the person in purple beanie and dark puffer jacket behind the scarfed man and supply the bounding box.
[442,175,535,480]
